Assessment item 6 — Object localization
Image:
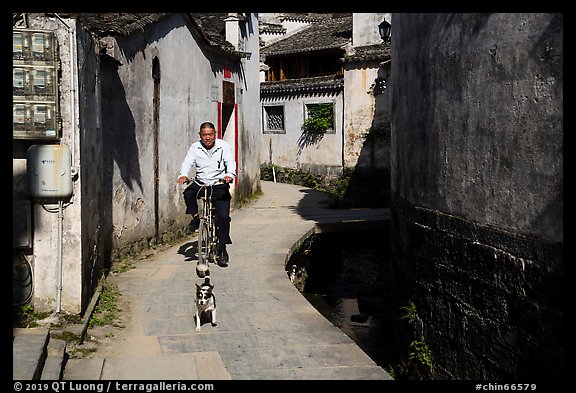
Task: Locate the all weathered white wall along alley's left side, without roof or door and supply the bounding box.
[13,14,260,313]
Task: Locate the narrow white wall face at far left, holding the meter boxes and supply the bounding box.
[13,17,85,313]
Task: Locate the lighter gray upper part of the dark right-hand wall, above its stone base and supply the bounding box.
[390,13,563,241]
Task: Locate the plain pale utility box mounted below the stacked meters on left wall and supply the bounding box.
[27,145,72,199]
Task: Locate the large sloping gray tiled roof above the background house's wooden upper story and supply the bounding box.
[260,16,352,57]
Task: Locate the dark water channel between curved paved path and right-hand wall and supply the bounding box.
[286,225,398,370]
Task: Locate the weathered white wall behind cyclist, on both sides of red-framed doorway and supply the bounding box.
[103,17,260,246]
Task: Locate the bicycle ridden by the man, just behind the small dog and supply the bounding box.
[186,179,222,278]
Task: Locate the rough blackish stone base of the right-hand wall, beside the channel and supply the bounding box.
[392,199,564,380]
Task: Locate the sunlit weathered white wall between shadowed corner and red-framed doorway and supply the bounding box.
[105,20,219,247]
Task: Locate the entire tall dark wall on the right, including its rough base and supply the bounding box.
[391,13,564,380]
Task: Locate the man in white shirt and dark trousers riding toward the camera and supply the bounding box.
[178,122,236,267]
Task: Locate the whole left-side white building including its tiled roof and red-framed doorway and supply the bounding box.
[13,14,260,313]
